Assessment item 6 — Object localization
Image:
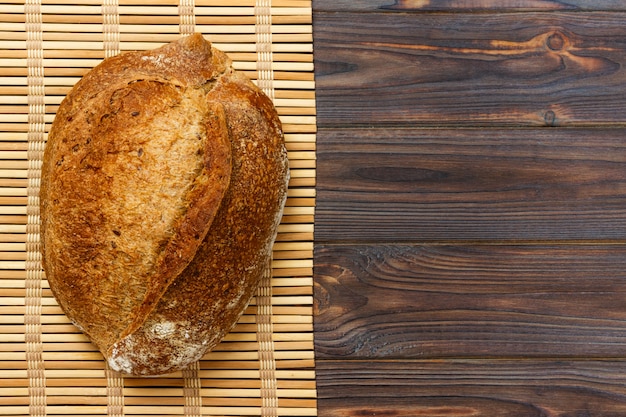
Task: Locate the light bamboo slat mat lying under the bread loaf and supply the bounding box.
[0,0,317,416]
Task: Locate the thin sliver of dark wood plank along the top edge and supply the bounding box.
[313,0,626,12]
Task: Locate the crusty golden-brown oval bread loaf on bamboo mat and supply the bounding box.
[41,34,289,375]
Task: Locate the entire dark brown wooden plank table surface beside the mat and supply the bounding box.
[313,0,626,417]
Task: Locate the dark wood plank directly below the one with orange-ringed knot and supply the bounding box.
[315,129,626,243]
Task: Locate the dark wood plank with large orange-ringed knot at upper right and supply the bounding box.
[314,12,626,127]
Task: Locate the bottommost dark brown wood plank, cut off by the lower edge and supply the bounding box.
[317,360,626,417]
